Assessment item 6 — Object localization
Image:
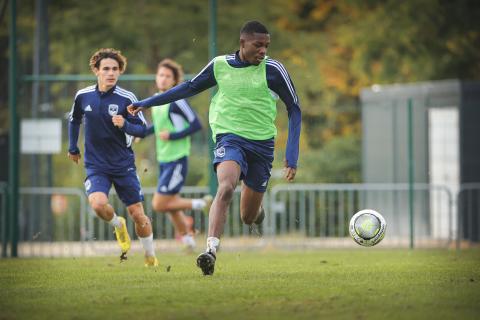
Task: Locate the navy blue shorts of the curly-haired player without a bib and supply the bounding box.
[84,168,143,207]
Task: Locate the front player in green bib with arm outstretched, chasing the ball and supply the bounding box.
[128,21,301,275]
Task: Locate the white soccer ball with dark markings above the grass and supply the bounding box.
[349,209,387,247]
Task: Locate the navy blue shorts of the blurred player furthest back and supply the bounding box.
[157,157,188,194]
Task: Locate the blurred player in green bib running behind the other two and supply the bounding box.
[143,59,212,250]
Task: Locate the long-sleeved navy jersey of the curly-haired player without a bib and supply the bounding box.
[68,85,147,174]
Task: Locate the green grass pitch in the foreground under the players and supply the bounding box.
[0,248,480,320]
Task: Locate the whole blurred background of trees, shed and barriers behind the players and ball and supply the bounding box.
[0,0,480,256]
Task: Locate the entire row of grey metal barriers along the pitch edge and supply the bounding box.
[0,184,480,257]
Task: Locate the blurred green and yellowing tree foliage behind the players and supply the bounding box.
[0,0,480,185]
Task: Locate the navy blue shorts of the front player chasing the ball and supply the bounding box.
[213,133,275,193]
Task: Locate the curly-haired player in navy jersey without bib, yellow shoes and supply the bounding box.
[68,48,158,266]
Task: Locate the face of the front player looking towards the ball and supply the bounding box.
[240,33,270,65]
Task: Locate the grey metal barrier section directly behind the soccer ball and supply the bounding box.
[269,184,456,245]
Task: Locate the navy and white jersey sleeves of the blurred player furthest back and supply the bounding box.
[147,99,202,140]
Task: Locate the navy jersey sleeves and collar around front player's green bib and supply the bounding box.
[133,51,302,168]
